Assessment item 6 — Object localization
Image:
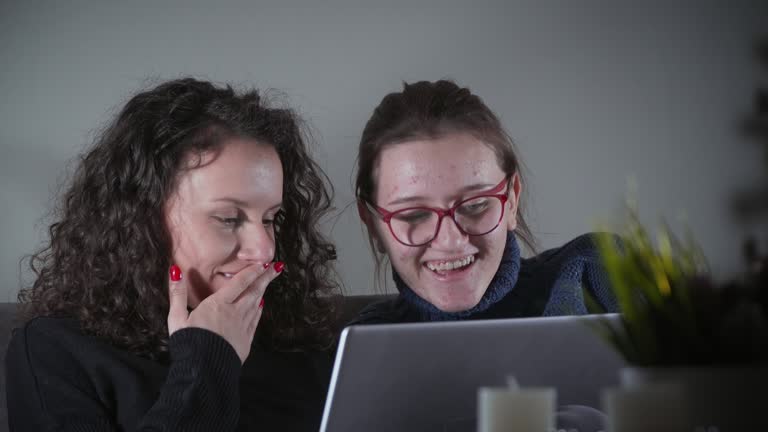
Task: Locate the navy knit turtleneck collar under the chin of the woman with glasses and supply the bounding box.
[392,231,520,321]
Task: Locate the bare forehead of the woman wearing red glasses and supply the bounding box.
[376,134,504,198]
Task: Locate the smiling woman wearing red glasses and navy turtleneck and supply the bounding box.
[353,81,617,324]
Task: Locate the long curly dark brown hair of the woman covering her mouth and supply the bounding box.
[19,78,338,358]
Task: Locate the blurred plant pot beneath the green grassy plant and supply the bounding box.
[619,366,768,432]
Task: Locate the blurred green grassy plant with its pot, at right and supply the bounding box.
[596,211,768,432]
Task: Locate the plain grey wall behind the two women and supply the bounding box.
[0,0,768,301]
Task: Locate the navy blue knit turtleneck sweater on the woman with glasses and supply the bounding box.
[351,232,618,324]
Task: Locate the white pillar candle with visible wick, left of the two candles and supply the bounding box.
[477,387,557,432]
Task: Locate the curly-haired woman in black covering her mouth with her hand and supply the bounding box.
[6,78,337,431]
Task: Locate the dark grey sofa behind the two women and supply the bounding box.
[0,295,391,432]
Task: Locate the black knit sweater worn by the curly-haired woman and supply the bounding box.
[5,318,332,432]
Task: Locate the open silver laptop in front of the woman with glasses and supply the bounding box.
[320,314,624,432]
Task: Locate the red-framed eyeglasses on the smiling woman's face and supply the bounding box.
[364,176,510,246]
